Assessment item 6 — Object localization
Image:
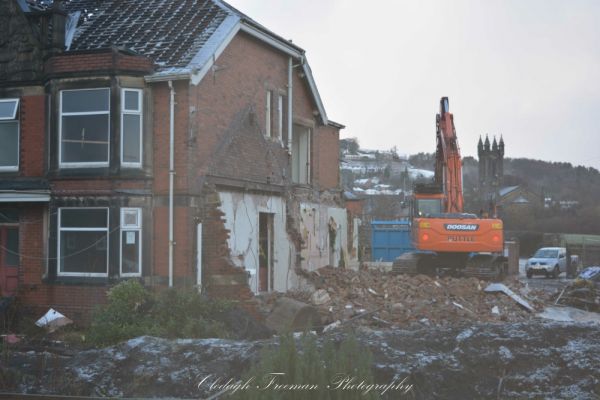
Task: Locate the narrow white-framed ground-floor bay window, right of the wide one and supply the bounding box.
[121,208,142,276]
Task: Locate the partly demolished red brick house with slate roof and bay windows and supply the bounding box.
[0,0,355,320]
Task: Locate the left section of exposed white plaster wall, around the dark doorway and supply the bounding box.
[219,191,295,293]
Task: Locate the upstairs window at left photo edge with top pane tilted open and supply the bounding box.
[0,99,19,171]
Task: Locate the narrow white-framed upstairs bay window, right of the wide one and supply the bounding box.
[121,89,143,168]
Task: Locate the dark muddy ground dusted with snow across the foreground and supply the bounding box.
[3,320,600,399]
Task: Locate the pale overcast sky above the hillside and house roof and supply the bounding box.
[229,0,600,168]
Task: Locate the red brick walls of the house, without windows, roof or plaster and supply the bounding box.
[0,3,339,322]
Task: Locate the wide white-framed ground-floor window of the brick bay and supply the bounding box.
[58,208,108,276]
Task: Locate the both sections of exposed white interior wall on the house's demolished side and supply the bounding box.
[219,191,354,293]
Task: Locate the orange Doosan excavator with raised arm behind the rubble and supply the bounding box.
[392,97,507,279]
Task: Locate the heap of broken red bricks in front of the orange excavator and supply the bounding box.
[276,267,542,327]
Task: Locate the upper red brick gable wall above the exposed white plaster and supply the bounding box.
[190,33,330,183]
